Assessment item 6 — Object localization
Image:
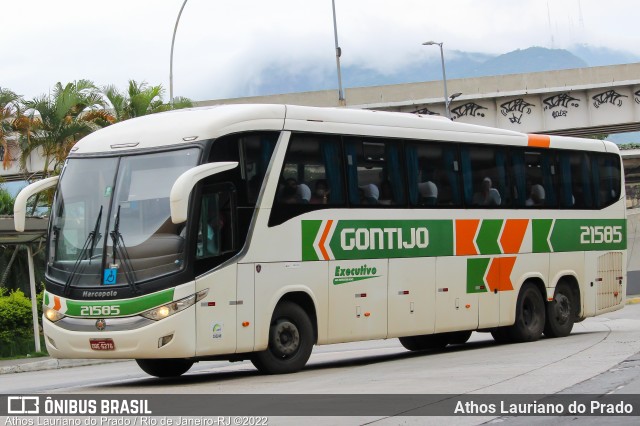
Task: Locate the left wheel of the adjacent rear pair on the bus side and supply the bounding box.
[508,283,545,343]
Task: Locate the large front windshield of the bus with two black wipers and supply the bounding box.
[47,149,199,288]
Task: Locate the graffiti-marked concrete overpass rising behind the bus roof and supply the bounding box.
[196,63,640,135]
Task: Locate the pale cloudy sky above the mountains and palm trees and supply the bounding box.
[0,0,640,101]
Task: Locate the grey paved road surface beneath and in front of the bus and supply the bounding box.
[0,304,640,425]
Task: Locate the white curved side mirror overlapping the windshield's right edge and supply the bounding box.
[169,161,238,225]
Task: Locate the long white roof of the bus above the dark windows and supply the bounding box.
[72,104,618,155]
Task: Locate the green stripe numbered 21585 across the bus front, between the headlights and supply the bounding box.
[65,288,174,317]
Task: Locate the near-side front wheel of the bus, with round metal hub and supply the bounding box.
[251,302,315,374]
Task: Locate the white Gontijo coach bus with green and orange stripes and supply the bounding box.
[15,104,627,377]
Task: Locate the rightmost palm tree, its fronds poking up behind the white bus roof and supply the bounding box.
[102,80,193,121]
